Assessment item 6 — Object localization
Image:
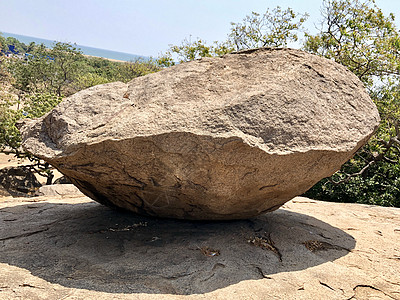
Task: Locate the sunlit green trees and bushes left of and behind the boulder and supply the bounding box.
[0,35,159,184]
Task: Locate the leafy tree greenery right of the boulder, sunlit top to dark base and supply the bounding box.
[304,0,400,206]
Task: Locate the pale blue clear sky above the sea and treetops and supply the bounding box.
[0,0,400,57]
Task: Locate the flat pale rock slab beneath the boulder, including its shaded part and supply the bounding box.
[0,197,400,300]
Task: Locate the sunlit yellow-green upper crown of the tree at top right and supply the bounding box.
[304,0,400,87]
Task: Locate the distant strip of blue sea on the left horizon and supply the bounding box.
[1,32,148,61]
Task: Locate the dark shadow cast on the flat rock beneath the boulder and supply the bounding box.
[0,202,355,295]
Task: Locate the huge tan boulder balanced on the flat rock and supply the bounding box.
[22,49,379,219]
